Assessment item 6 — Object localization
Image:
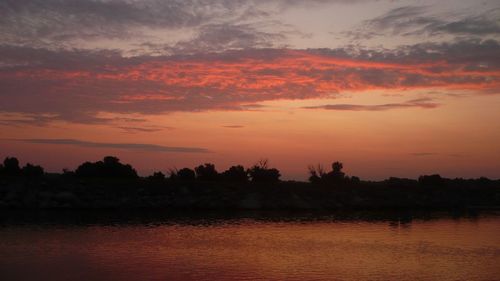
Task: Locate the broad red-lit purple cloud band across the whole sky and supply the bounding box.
[0,40,500,124]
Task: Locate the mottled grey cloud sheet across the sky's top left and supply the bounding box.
[0,0,347,51]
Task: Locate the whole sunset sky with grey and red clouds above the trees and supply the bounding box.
[0,0,500,180]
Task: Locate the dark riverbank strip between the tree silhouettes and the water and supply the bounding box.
[0,175,500,210]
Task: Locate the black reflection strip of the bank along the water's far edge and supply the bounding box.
[0,209,488,227]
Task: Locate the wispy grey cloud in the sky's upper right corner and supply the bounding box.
[345,6,500,40]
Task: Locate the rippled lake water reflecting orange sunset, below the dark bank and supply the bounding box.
[0,212,500,281]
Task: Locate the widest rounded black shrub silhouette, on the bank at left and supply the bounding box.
[75,156,138,178]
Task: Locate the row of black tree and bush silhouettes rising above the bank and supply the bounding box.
[0,156,498,186]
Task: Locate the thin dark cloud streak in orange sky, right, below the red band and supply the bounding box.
[304,98,439,111]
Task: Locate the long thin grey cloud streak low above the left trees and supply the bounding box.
[18,139,210,153]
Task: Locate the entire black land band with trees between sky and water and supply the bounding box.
[0,156,500,209]
